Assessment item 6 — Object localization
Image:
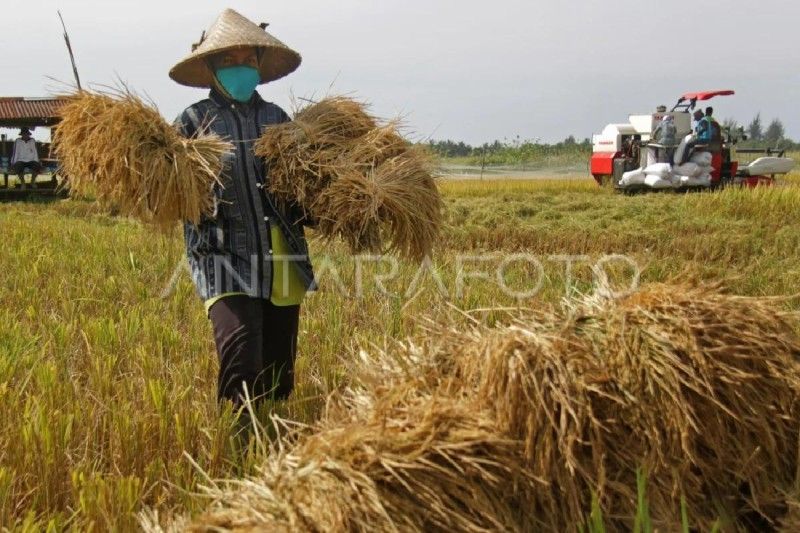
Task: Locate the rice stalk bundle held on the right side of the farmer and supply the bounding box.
[255,97,442,259]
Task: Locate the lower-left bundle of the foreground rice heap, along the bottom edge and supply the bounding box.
[182,394,536,532]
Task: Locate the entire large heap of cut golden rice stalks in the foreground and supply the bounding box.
[158,286,800,531]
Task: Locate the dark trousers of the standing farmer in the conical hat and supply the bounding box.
[209,296,300,408]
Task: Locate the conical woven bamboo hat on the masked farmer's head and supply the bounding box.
[169,9,301,87]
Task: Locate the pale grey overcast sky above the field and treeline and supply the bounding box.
[6,0,800,143]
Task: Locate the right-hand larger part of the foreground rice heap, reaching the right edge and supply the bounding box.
[438,286,800,531]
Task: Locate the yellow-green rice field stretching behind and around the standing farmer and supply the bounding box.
[0,176,800,531]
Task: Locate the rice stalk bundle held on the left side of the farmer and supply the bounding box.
[53,91,231,227]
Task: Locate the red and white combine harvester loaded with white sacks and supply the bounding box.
[591,90,794,192]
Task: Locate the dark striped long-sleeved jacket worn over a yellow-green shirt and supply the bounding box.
[176,90,316,300]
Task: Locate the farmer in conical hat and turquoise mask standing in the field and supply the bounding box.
[170,9,315,418]
